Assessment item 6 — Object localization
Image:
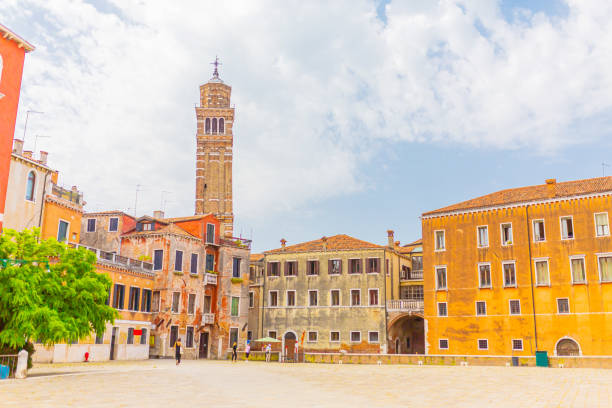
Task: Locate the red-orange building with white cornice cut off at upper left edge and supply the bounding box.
[0,24,34,230]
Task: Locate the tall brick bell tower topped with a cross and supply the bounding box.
[195,58,234,237]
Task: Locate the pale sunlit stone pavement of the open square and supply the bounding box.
[0,360,612,408]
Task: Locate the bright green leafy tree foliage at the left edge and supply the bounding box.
[0,228,118,351]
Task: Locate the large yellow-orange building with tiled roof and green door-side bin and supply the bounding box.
[422,177,612,356]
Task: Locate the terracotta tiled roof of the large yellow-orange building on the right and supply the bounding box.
[423,176,612,216]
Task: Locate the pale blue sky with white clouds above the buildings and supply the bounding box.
[0,0,612,251]
